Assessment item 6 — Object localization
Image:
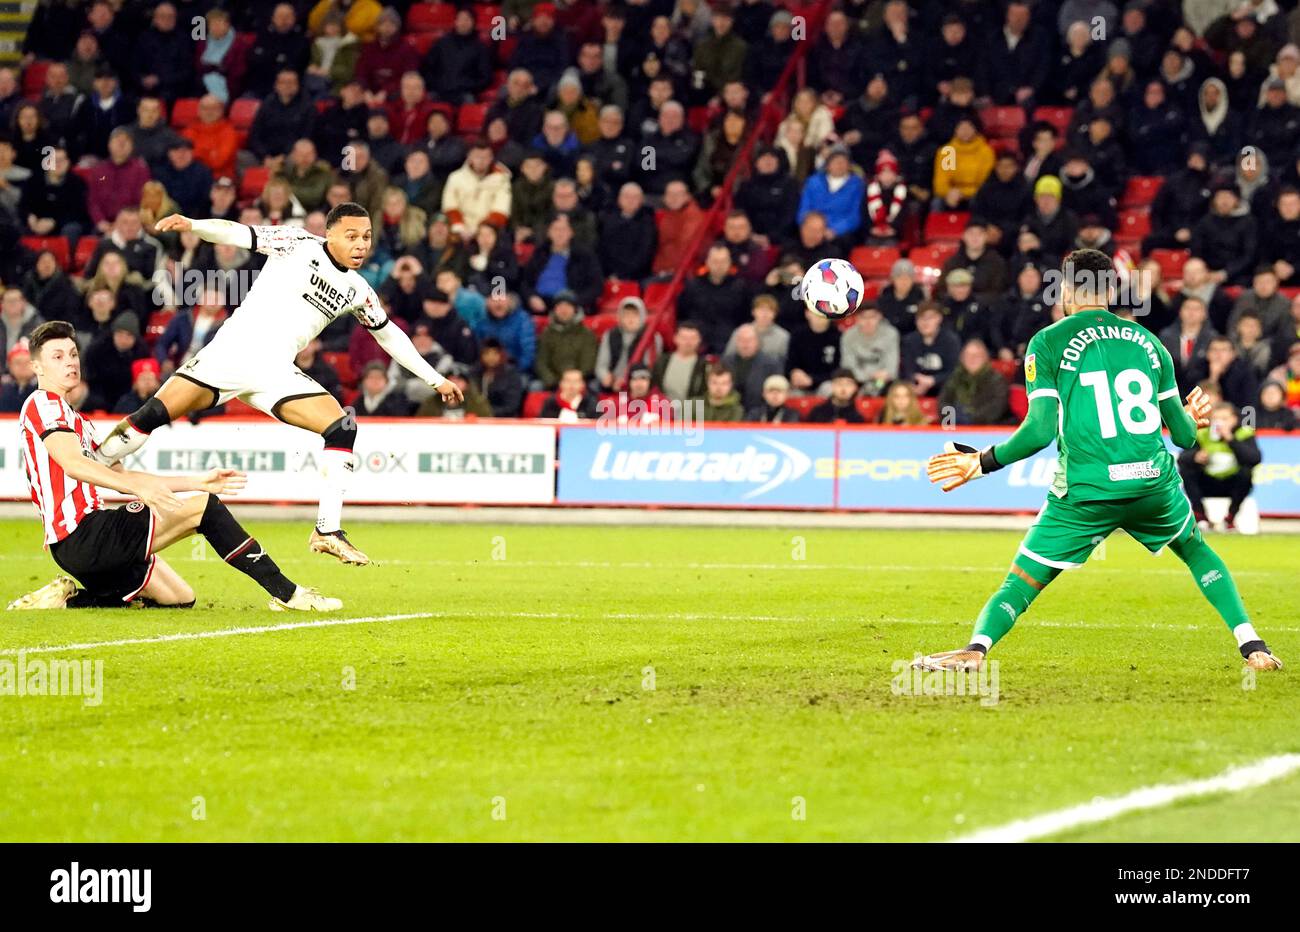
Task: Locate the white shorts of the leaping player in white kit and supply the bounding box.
[176,334,329,420]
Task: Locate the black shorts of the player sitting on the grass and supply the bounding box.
[49,502,157,602]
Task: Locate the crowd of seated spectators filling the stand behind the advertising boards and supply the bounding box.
[0,0,1300,429]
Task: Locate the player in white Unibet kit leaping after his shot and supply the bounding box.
[99,203,463,565]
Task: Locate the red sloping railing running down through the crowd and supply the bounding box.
[618,0,833,390]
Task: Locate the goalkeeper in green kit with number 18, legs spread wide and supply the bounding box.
[913,250,1282,671]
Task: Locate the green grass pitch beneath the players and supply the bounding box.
[0,517,1300,841]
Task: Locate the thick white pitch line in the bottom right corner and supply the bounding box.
[953,754,1300,844]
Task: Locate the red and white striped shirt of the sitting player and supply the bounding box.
[18,389,104,547]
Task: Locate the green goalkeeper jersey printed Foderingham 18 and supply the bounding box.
[1024,308,1179,502]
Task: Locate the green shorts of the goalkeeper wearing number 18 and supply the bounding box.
[1019,484,1196,569]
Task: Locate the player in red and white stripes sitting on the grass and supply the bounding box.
[9,321,343,611]
